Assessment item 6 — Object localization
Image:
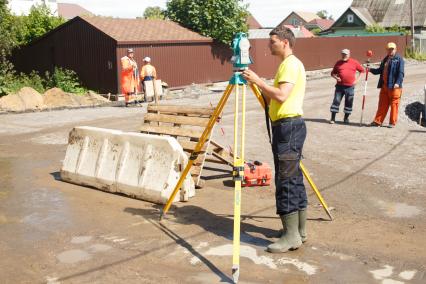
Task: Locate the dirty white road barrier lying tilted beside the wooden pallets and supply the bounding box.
[61,126,195,204]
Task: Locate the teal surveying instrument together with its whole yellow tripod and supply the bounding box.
[160,33,333,283]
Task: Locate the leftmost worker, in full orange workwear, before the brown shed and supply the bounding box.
[121,48,139,106]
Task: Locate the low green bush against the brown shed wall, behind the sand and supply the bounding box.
[45,68,87,94]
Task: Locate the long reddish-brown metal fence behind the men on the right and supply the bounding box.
[250,36,409,78]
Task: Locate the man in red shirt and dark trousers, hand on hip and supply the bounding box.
[330,49,364,124]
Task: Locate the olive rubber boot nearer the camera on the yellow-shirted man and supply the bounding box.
[267,211,302,253]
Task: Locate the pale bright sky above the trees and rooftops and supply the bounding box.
[58,0,352,27]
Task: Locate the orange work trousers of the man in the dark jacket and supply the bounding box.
[374,86,402,125]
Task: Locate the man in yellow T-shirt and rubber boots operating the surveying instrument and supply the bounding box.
[243,27,307,253]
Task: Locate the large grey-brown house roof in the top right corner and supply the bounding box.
[351,0,426,27]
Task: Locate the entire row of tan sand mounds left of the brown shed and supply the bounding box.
[0,87,109,112]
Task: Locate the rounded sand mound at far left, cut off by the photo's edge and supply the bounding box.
[0,87,44,111]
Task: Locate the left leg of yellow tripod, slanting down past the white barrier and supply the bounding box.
[160,85,234,221]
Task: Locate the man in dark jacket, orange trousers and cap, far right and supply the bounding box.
[370,42,404,128]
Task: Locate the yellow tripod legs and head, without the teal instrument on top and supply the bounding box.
[160,74,333,283]
